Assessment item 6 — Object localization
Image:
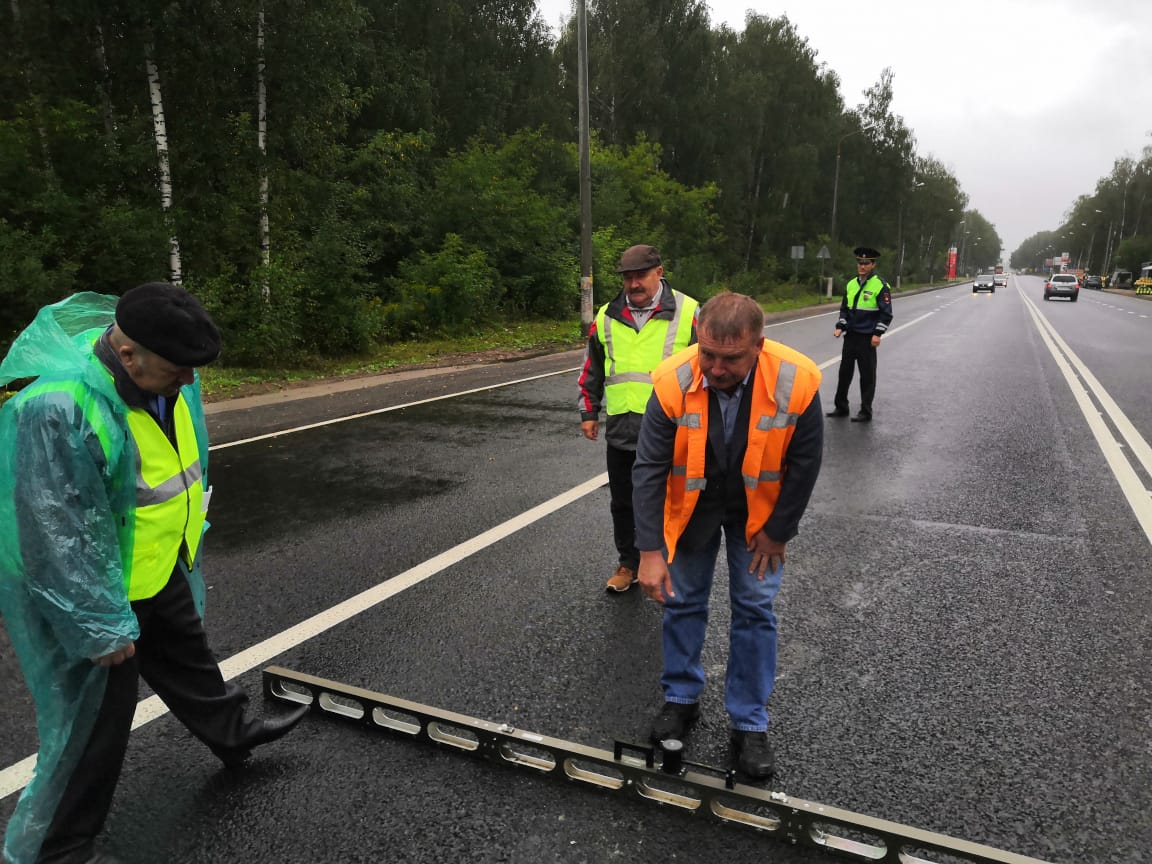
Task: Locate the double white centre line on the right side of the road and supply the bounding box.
[1021,293,1152,543]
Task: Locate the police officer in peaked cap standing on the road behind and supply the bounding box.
[827,247,892,423]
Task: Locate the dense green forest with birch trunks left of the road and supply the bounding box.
[0,0,1004,364]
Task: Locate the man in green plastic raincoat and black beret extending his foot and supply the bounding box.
[0,288,308,864]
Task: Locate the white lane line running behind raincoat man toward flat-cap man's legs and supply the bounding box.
[0,472,608,799]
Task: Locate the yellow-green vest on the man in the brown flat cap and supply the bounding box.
[596,290,699,415]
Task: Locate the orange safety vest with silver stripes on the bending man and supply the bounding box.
[652,340,820,561]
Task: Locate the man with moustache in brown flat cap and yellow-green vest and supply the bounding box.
[579,244,699,592]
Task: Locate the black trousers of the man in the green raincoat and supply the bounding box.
[39,571,258,864]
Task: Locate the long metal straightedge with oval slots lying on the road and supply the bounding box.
[264,666,1046,864]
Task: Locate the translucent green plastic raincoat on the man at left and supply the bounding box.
[0,293,207,864]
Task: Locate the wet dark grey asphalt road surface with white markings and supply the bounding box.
[0,276,1152,864]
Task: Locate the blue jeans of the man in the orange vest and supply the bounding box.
[660,529,783,732]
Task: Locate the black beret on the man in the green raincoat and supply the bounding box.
[116,282,220,367]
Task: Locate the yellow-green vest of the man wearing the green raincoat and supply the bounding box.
[128,397,204,600]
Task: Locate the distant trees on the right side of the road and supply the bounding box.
[1010,146,1152,275]
